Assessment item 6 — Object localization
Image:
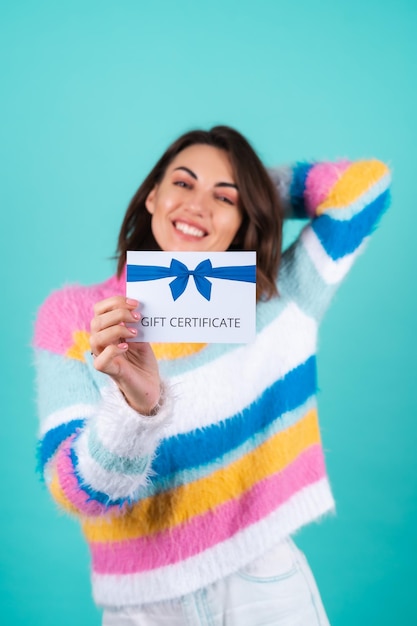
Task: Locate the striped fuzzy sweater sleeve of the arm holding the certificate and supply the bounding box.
[34,288,170,516]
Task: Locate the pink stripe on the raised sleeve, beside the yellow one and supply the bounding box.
[304,160,351,217]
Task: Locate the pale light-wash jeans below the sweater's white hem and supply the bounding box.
[103,539,329,626]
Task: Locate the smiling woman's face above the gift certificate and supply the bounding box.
[146,144,242,252]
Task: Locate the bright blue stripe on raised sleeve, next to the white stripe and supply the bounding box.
[312,190,389,261]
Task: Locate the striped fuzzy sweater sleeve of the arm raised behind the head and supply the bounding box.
[270,159,391,321]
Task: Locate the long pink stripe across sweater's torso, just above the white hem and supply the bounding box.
[90,445,325,574]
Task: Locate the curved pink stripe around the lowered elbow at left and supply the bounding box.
[56,435,126,516]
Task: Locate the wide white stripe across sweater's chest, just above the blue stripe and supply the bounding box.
[162,302,317,436]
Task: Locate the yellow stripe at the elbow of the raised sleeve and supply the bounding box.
[316,159,389,215]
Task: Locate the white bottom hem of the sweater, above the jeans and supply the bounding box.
[92,478,335,609]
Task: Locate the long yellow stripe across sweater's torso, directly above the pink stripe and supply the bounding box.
[83,409,320,541]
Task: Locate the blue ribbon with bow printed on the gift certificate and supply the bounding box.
[127,259,256,300]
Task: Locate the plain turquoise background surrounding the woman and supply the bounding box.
[0,0,417,626]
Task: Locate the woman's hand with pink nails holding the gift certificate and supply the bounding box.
[90,296,161,415]
